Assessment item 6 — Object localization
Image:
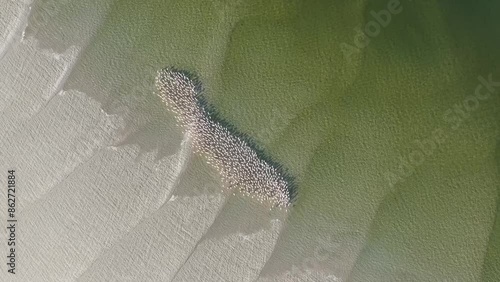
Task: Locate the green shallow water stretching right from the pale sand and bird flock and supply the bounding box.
[31,0,500,281]
